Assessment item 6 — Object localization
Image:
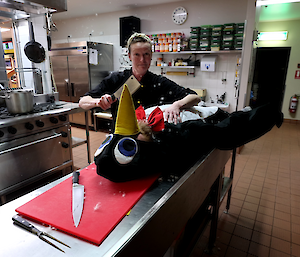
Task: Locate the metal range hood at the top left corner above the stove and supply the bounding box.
[0,0,67,22]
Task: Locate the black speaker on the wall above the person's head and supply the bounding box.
[120,16,141,47]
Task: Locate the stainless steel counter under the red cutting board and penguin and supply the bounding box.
[0,150,230,257]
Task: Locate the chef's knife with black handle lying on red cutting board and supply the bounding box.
[72,171,84,227]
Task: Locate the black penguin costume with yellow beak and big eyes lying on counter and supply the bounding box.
[94,85,283,182]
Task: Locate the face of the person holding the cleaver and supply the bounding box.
[128,42,152,76]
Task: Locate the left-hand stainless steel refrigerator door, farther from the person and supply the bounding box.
[51,56,71,102]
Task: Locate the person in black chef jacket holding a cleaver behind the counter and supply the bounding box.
[79,33,200,124]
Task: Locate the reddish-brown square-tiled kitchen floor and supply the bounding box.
[72,123,300,257]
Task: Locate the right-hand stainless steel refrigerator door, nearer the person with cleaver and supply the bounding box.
[68,55,90,103]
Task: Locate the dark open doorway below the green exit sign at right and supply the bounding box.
[250,47,291,110]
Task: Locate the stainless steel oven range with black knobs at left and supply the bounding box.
[0,103,73,202]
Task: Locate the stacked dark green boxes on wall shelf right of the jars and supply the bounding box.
[190,23,244,51]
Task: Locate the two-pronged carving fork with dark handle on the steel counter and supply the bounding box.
[12,215,71,252]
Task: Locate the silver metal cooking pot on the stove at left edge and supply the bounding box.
[0,90,34,114]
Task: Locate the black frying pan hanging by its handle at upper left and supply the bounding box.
[24,22,45,63]
